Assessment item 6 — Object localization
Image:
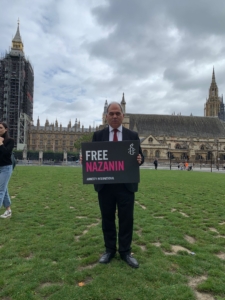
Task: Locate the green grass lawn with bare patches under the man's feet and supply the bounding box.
[0,167,225,300]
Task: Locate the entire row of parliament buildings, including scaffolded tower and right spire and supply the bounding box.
[0,24,225,162]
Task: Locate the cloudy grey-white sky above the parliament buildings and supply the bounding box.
[0,0,225,127]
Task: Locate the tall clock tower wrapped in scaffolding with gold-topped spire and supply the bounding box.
[0,23,34,150]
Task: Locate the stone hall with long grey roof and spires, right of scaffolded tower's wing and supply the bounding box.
[102,74,225,163]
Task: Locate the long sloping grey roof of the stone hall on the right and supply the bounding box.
[126,114,225,138]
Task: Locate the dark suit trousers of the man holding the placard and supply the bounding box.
[98,184,134,256]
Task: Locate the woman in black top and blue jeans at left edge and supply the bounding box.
[0,122,14,219]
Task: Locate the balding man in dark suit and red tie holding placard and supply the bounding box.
[92,102,144,268]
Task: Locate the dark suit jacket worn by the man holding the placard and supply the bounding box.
[92,127,144,192]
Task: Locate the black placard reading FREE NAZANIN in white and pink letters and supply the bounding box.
[82,140,140,184]
